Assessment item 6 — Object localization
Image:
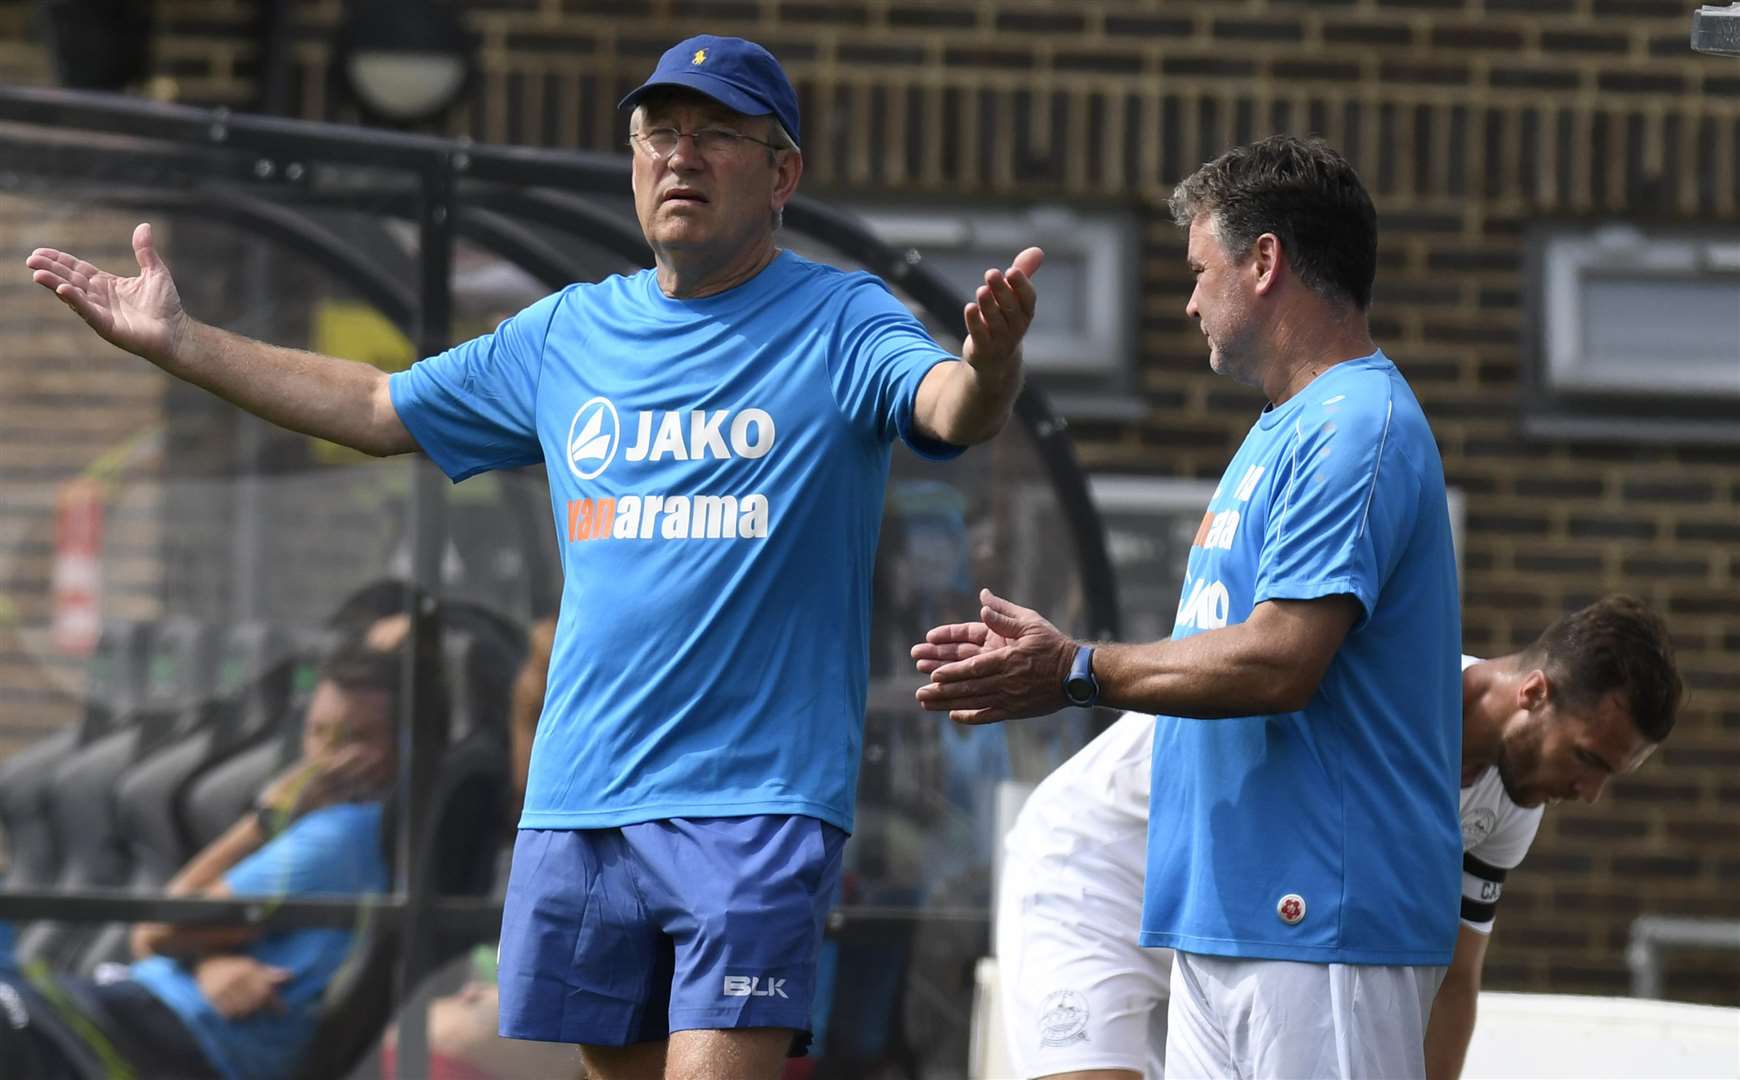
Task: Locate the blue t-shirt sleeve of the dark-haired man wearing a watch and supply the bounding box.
[1253,391,1420,624]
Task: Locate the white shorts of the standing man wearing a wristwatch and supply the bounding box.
[1166,953,1444,1080]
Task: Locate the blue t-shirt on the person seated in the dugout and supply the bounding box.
[132,802,388,1080]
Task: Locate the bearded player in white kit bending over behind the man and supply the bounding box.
[953,597,1681,1080]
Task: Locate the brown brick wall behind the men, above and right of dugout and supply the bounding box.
[0,0,1740,1003]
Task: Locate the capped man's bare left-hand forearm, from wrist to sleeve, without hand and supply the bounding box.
[163,318,418,456]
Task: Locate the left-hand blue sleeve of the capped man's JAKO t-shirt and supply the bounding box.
[388,290,569,483]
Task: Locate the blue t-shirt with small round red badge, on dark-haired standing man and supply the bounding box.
[1141,353,1462,965]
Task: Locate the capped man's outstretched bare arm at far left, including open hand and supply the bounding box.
[24,224,418,456]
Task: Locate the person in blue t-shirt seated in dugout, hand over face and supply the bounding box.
[0,614,433,1080]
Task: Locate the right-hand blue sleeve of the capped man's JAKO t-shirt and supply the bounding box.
[828,273,962,461]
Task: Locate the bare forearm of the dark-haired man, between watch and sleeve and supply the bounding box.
[1093,623,1315,720]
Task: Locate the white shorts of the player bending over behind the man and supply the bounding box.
[997,859,1173,1080]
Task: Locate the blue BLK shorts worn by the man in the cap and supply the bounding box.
[498,814,846,1047]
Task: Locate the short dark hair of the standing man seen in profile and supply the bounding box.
[1169,136,1378,311]
